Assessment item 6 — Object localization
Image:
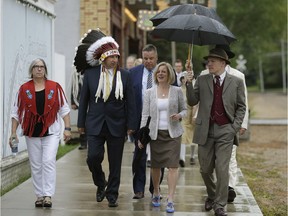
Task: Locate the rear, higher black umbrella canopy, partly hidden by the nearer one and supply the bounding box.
[150,4,223,26]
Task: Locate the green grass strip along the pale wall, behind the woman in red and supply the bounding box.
[0,143,78,196]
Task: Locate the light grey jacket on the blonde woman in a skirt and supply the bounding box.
[141,85,187,140]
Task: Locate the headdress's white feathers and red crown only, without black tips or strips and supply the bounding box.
[86,36,120,66]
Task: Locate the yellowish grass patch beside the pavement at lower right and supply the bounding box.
[237,153,287,216]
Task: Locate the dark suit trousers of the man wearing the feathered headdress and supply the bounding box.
[87,123,125,200]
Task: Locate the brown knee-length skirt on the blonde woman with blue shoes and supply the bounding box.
[150,130,181,168]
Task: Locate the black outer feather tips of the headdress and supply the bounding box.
[73,29,106,72]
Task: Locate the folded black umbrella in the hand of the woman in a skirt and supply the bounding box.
[132,116,151,174]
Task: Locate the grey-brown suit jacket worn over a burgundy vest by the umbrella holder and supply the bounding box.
[186,73,246,145]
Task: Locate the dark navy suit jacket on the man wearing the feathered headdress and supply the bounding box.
[77,66,136,137]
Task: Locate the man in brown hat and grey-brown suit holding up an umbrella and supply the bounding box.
[186,48,246,216]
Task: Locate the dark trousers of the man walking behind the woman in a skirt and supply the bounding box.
[132,141,164,194]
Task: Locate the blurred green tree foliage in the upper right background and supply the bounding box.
[217,0,287,87]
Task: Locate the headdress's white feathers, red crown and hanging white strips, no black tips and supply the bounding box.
[86,36,123,103]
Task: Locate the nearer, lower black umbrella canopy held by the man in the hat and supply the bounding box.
[151,14,236,46]
